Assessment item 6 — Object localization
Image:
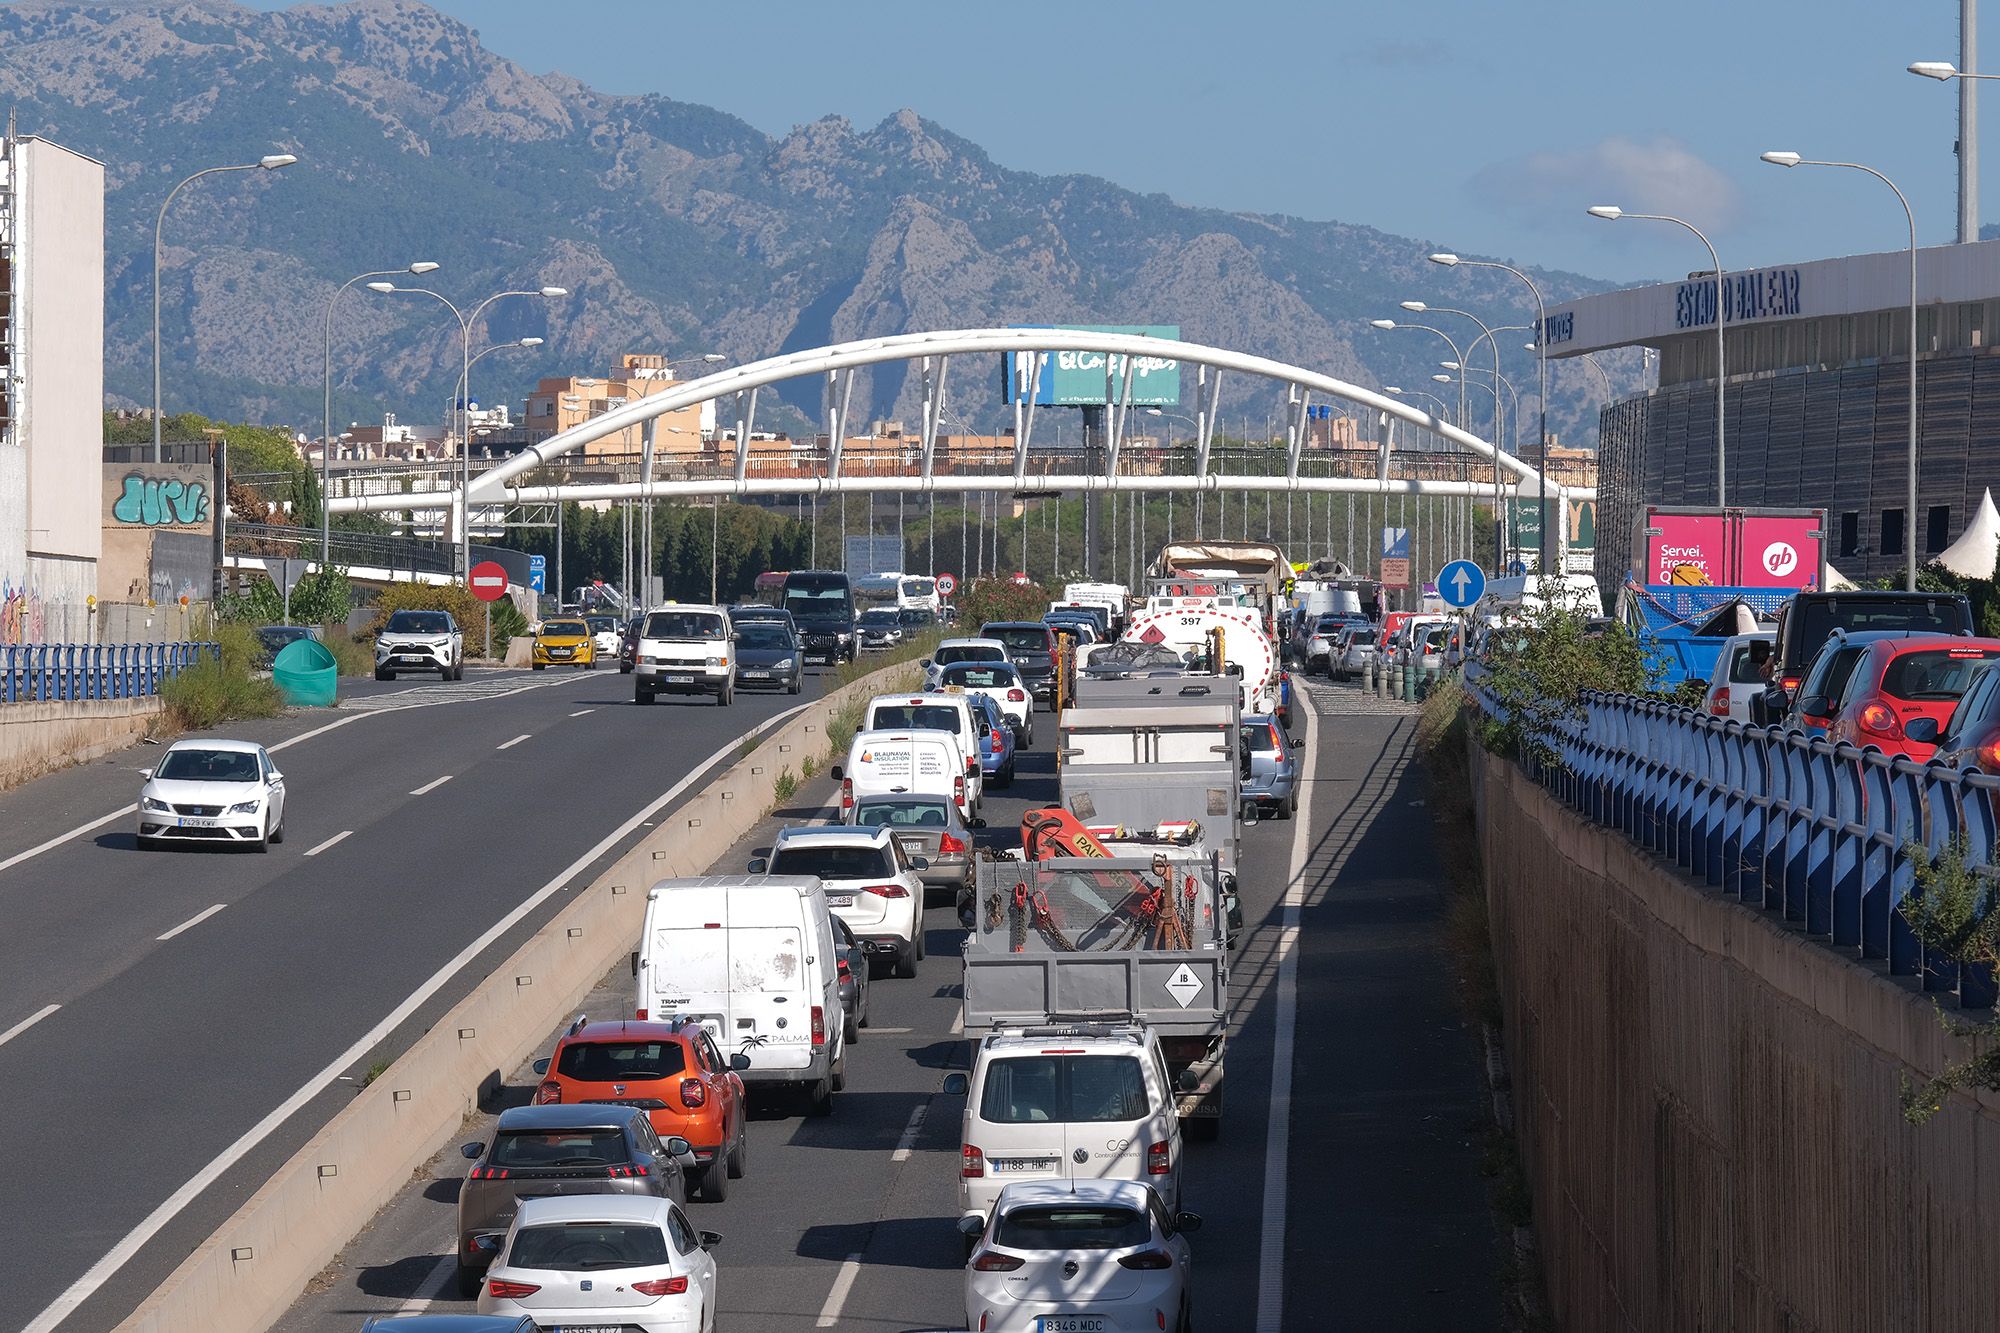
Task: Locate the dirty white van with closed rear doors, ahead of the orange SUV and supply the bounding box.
[632,875,848,1115]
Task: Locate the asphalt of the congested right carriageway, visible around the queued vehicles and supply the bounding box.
[276,683,1500,1333]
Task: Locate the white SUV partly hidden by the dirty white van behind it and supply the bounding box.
[750,825,930,977]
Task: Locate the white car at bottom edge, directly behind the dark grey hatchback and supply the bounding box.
[478,1195,722,1333]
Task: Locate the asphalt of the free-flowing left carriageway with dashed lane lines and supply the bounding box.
[0,671,818,1329]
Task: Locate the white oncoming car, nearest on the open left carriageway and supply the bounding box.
[138,741,284,851]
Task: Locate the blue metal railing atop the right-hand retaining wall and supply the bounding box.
[1468,681,2000,1009]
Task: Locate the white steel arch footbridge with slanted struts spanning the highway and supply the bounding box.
[328,328,1596,512]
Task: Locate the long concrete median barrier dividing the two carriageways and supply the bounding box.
[129,662,914,1333]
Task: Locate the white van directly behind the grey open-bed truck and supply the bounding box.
[944,1023,1182,1221]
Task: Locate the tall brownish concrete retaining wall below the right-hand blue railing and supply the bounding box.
[1472,747,2000,1333]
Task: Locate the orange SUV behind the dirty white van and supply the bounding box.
[534,1015,750,1203]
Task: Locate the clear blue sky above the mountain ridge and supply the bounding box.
[260,0,1976,278]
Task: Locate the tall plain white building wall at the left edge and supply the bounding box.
[14,138,104,600]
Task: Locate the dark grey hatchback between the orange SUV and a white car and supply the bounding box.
[458,1103,694,1297]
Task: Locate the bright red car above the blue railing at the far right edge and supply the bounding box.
[1826,634,2000,763]
